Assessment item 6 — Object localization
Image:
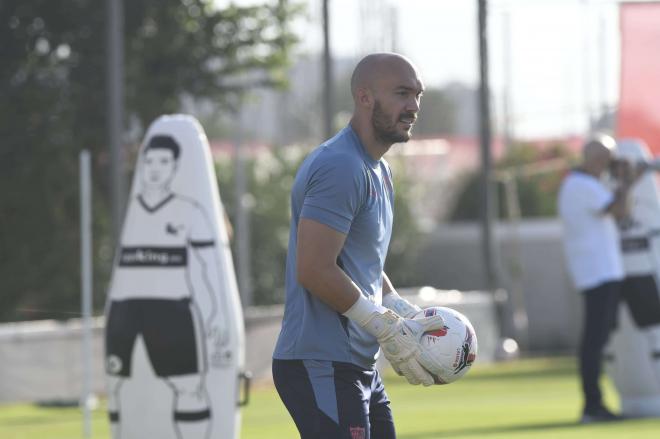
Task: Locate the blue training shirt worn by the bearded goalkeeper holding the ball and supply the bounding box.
[273,125,394,369]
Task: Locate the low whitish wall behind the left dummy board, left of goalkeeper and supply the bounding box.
[0,307,282,404]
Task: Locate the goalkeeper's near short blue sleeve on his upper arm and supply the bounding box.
[300,154,367,234]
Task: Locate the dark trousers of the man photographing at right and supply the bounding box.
[579,281,622,411]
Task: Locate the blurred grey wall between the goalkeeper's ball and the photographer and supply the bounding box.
[415,219,582,352]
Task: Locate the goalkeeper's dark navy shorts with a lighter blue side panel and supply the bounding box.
[273,359,396,439]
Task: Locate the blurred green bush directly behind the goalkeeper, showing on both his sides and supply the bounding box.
[216,147,419,305]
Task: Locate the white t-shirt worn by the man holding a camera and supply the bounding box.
[558,171,624,290]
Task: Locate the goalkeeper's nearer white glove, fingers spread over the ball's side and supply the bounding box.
[344,295,445,386]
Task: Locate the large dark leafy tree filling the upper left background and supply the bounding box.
[0,0,297,321]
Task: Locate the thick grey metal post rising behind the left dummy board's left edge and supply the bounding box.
[106,0,124,241]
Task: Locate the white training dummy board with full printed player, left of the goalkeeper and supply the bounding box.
[105,115,244,439]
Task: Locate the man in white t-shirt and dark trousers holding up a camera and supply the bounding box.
[558,135,641,423]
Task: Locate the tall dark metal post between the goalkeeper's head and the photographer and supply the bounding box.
[478,0,498,291]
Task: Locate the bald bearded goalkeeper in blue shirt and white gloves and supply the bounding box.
[273,53,444,439]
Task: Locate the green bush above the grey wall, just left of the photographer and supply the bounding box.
[449,144,575,221]
